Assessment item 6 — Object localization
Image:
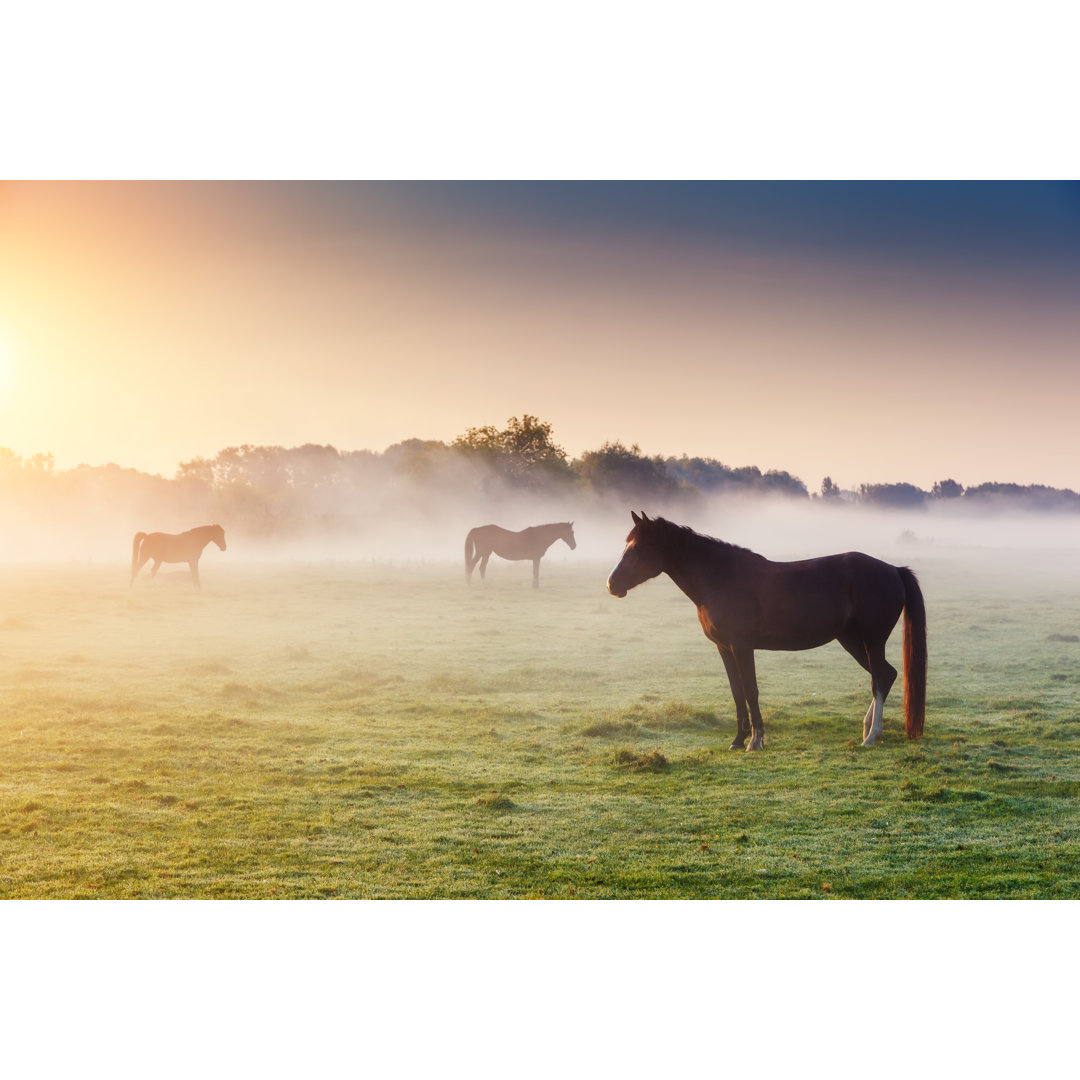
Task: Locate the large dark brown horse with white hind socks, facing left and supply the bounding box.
[607,513,927,750]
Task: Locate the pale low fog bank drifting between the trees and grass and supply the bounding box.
[8,462,1080,579]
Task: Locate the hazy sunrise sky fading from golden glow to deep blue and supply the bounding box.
[0,181,1080,489]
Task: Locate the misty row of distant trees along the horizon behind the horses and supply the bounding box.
[0,414,1080,548]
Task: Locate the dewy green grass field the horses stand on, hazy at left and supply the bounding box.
[0,539,1080,899]
